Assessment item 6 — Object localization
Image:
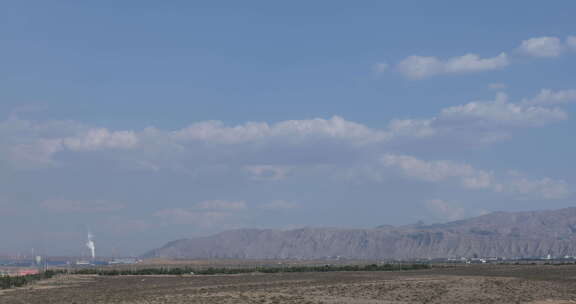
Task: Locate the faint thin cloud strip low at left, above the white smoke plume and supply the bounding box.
[40,199,125,213]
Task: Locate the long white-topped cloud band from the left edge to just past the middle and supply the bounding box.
[0,116,382,170]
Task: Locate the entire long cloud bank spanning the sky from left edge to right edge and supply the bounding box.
[0,90,576,172]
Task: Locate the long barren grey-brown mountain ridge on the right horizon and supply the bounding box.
[144,208,576,259]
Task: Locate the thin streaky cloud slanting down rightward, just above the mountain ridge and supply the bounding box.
[380,154,572,199]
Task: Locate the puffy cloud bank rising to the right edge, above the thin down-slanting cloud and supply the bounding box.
[387,90,572,144]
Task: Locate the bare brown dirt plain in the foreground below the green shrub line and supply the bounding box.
[0,265,576,304]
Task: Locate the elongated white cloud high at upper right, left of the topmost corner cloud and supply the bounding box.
[397,53,509,79]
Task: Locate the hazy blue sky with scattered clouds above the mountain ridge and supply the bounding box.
[0,0,576,256]
